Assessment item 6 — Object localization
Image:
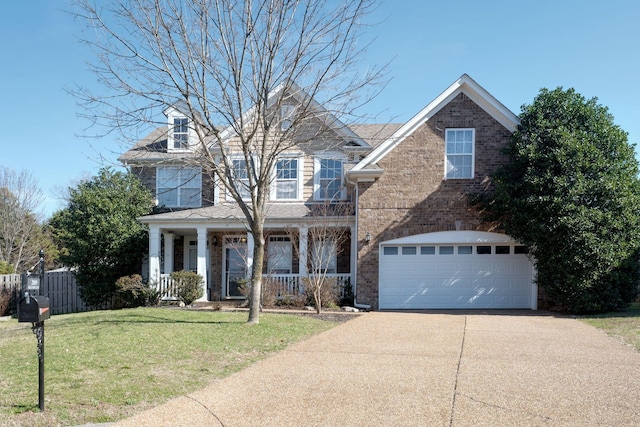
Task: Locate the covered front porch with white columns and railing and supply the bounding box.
[143,206,357,301]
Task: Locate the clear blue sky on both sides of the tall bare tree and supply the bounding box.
[0,0,640,221]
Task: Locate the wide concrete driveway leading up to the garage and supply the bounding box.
[116,311,640,427]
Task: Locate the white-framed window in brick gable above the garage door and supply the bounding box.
[445,129,475,179]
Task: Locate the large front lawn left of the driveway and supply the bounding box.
[0,308,335,426]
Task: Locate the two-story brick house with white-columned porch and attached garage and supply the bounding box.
[120,75,537,309]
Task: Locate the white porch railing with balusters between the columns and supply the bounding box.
[156,273,351,301]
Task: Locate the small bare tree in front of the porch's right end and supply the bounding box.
[287,202,353,314]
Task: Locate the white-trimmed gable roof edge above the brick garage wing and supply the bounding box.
[349,74,518,173]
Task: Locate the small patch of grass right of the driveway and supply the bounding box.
[582,303,640,351]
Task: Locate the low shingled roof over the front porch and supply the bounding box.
[138,203,356,224]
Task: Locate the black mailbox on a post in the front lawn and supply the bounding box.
[18,250,51,411]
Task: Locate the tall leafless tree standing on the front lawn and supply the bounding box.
[74,0,385,323]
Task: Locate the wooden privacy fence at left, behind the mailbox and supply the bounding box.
[0,271,111,314]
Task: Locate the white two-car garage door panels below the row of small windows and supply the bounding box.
[379,237,534,309]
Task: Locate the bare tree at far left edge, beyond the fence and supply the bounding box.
[0,166,44,272]
